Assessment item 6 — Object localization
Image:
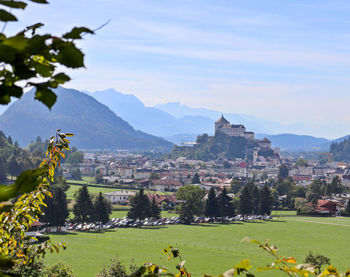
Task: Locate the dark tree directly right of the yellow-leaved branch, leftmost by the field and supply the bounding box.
[40,185,69,226]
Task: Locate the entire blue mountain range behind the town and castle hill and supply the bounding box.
[0,88,346,151]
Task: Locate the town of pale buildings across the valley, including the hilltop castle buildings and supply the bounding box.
[62,116,350,215]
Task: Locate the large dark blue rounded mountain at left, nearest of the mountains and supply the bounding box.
[0,87,173,152]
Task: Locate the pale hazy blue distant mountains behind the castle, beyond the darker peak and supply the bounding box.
[89,89,346,151]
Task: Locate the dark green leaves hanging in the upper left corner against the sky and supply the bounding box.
[0,0,93,109]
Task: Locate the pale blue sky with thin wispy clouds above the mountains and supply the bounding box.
[5,0,350,138]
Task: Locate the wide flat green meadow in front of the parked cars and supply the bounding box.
[47,217,350,277]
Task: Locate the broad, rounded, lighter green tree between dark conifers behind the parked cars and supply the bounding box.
[176,185,205,224]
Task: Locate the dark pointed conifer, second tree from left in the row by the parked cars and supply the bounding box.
[73,185,93,222]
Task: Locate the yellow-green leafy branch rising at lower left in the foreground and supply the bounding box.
[0,130,69,273]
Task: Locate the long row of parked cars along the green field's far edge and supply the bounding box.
[67,215,272,231]
